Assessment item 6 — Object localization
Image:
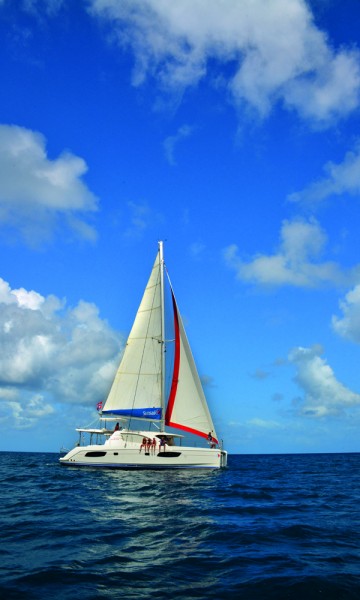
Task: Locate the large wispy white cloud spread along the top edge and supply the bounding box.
[90,0,360,122]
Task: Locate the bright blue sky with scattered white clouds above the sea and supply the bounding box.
[0,0,360,453]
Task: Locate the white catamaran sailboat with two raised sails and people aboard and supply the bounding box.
[60,242,227,469]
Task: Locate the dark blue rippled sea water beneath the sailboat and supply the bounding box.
[0,452,360,600]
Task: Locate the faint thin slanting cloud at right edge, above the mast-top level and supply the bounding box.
[289,143,360,202]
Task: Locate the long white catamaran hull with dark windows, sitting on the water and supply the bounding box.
[60,445,227,469]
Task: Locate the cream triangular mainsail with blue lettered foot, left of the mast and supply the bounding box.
[103,253,162,420]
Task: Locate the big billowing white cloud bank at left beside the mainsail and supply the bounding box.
[0,279,120,427]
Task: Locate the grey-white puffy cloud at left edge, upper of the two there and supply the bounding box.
[0,125,97,244]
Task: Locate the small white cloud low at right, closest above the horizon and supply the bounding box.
[289,347,360,418]
